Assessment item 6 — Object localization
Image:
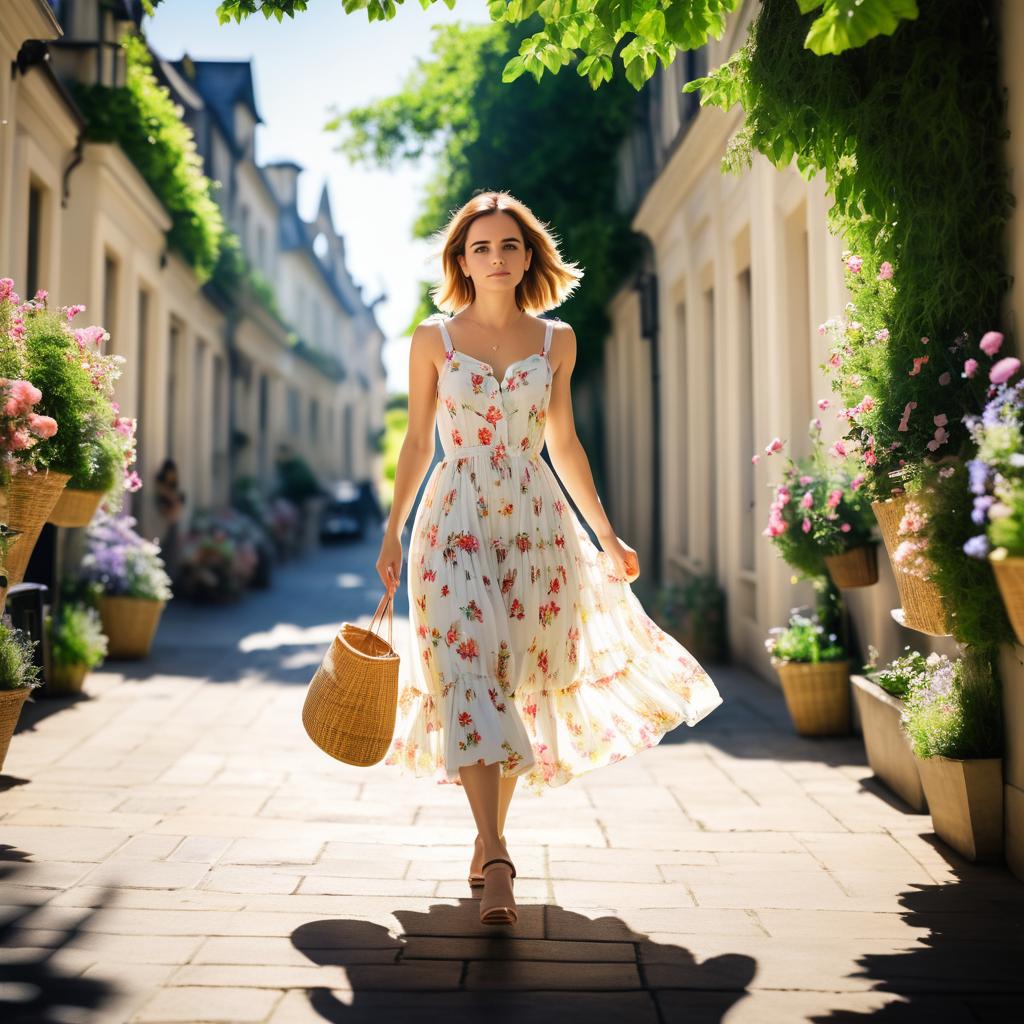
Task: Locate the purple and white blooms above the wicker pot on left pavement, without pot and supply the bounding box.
[78,510,171,601]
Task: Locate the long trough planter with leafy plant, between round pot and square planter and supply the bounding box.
[851,646,928,814]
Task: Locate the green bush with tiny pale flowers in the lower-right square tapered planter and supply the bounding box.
[902,651,1002,759]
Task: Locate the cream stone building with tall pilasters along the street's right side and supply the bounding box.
[604,3,1024,878]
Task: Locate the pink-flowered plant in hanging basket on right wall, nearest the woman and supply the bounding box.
[754,417,879,588]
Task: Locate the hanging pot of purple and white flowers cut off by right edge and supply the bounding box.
[964,352,1024,644]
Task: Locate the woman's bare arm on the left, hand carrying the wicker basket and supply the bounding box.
[377,324,442,594]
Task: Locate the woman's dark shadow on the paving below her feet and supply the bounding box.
[292,900,757,1024]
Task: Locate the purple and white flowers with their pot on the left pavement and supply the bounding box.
[79,509,171,658]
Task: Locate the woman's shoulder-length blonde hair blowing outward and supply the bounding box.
[430,191,584,313]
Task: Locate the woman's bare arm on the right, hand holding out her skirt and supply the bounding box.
[544,324,640,583]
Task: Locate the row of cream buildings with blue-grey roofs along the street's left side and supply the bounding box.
[0,0,385,535]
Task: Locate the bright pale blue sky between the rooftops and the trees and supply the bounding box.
[143,0,489,390]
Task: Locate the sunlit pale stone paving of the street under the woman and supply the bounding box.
[0,540,1024,1024]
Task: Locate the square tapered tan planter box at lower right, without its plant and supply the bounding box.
[914,755,1002,861]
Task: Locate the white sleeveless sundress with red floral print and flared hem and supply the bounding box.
[385,311,723,793]
